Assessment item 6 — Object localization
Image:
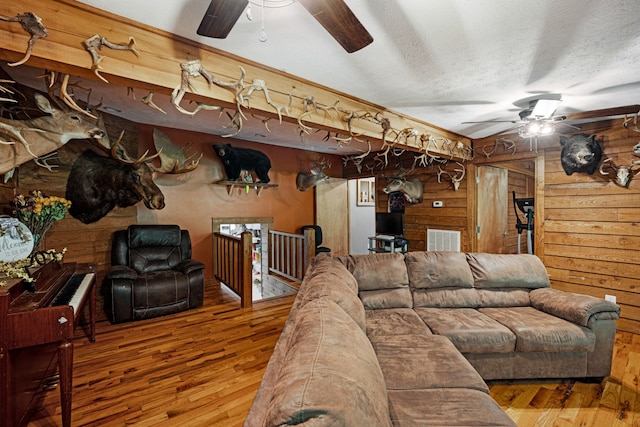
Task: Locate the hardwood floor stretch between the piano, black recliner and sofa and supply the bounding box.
[29,283,293,427]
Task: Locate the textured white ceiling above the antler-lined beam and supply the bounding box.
[62,0,640,144]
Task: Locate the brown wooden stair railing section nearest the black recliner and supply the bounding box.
[213,231,253,308]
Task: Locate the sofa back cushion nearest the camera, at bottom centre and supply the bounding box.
[264,298,391,426]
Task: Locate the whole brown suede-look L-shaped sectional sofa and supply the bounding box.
[244,252,619,427]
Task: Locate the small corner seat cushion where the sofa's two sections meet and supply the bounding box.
[365,308,432,337]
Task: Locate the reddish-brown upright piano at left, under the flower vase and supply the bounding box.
[0,261,96,427]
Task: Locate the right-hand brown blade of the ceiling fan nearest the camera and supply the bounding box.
[298,0,373,53]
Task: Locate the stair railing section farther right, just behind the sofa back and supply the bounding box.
[269,230,316,283]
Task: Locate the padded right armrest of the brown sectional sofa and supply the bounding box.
[529,288,620,327]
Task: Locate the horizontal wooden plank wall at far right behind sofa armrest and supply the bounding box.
[543,124,640,333]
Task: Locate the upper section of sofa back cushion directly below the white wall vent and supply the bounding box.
[405,251,473,289]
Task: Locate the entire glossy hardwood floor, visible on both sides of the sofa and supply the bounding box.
[29,283,640,427]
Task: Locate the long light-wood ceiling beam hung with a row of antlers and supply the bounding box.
[0,0,471,159]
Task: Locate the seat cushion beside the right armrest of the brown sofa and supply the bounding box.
[478,307,596,352]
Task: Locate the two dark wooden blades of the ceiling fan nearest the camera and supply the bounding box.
[197,0,373,53]
